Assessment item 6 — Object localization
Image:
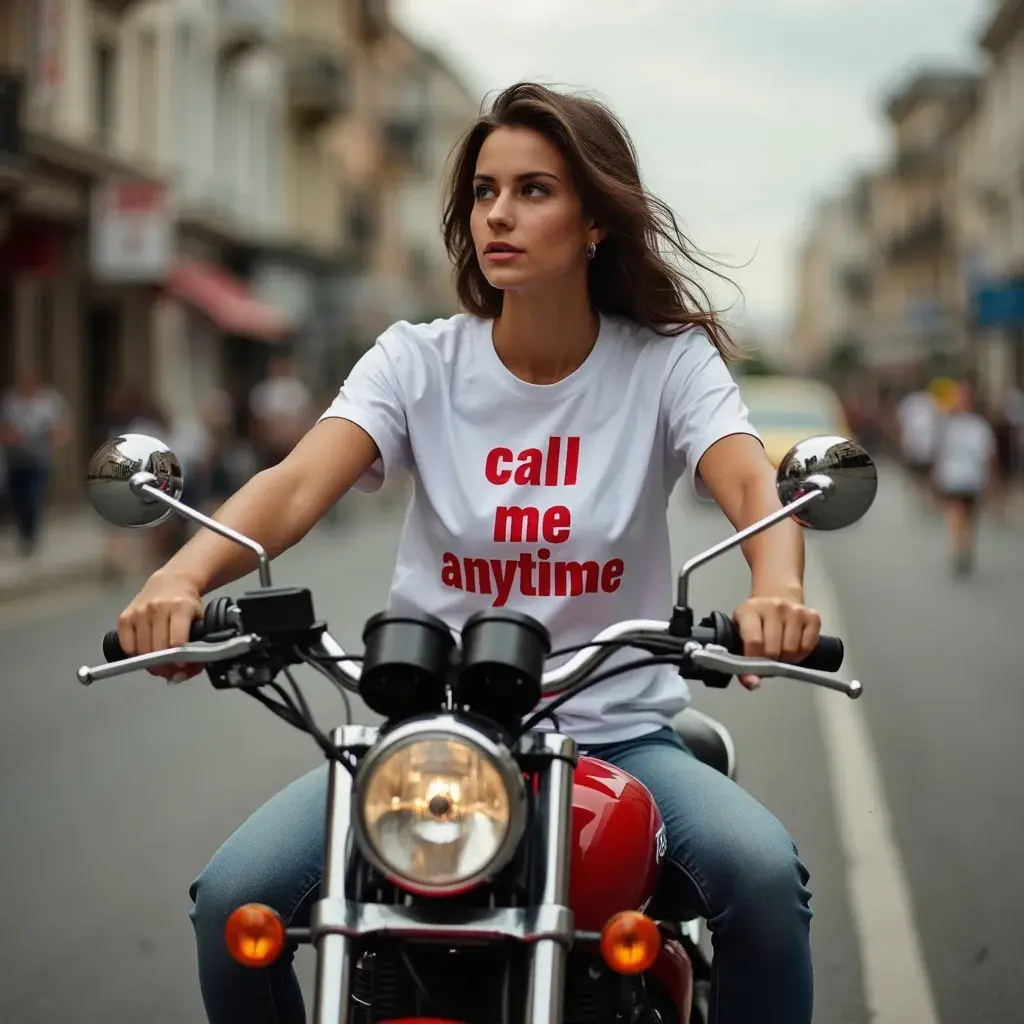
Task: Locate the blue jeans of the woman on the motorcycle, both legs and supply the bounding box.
[189,729,813,1024]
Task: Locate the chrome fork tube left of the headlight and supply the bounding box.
[313,726,376,1024]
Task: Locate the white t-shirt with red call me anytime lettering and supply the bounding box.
[325,314,757,743]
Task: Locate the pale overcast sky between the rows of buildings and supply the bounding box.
[393,0,997,348]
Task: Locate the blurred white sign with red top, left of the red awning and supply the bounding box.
[89,177,175,284]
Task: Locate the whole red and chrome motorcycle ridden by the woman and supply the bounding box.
[78,434,878,1024]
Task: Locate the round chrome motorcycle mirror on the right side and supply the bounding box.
[775,434,879,530]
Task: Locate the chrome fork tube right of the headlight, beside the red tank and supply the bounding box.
[526,733,577,1024]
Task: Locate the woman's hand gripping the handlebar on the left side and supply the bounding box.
[118,569,203,682]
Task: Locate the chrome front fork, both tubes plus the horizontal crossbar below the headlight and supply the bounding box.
[309,725,578,1024]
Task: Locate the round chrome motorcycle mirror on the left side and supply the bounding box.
[85,434,184,529]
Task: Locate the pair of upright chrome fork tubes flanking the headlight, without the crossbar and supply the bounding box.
[310,725,577,1024]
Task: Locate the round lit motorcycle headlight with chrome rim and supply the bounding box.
[355,718,526,895]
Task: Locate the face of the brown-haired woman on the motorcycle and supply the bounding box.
[470,128,601,291]
